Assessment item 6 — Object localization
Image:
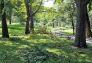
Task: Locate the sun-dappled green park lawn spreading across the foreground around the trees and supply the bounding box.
[0,24,92,63]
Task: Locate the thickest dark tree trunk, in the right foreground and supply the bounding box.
[75,0,87,48]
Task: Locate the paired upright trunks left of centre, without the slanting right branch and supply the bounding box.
[25,0,34,34]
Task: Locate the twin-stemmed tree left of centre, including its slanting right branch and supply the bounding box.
[25,0,43,34]
